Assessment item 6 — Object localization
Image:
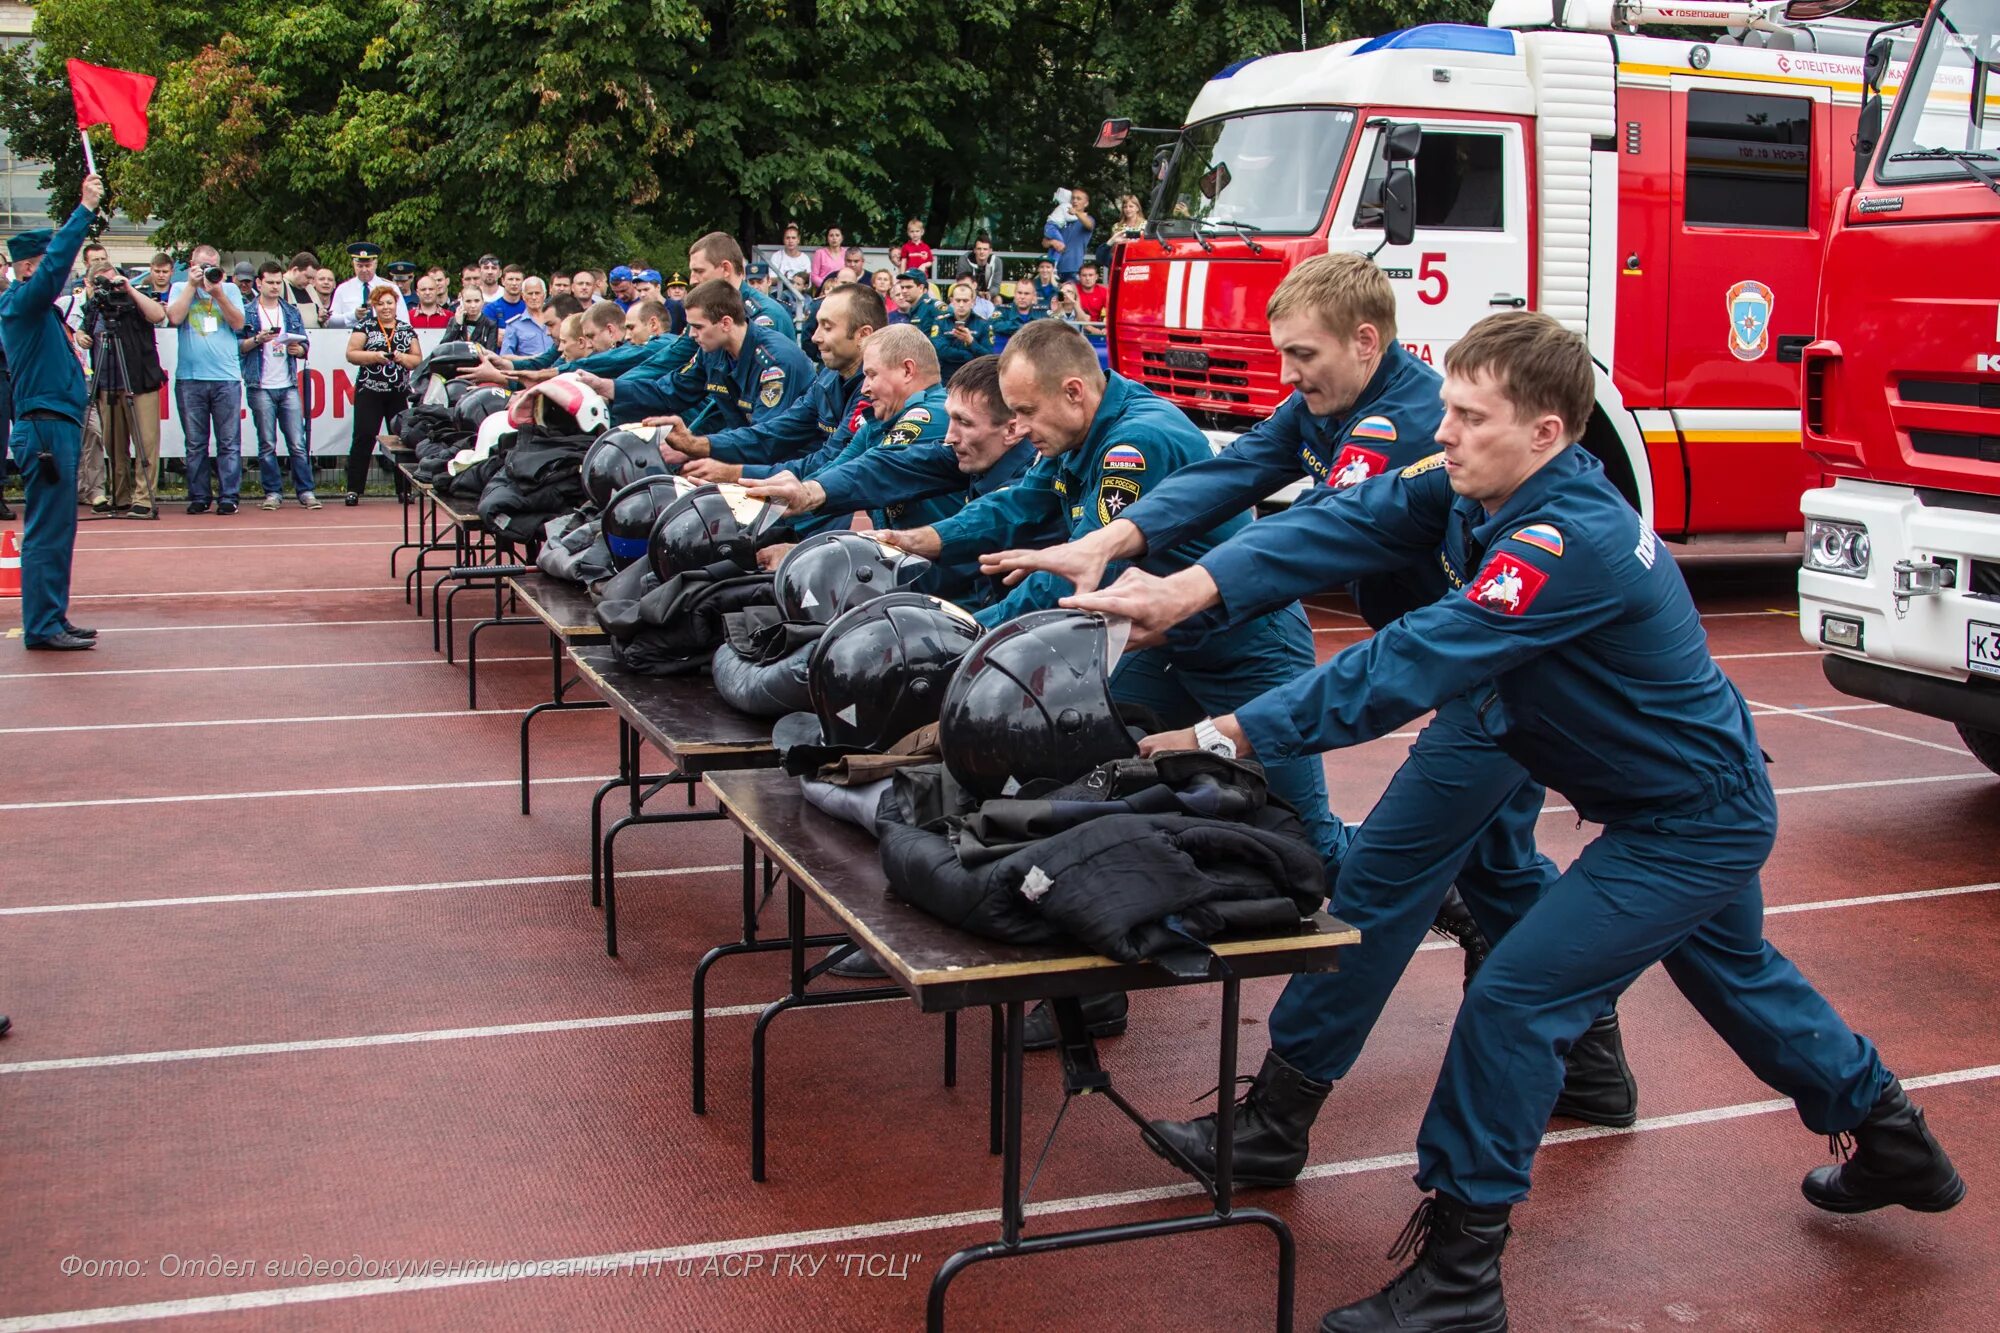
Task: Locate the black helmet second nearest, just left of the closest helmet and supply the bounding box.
[806,592,980,753]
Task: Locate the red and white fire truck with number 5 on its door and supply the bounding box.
[1100,0,1896,538]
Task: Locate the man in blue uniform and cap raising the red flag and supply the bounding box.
[0,176,104,652]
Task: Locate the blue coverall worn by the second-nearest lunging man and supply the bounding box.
[1124,344,1556,1081]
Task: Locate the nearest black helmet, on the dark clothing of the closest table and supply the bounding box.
[938,610,1136,801]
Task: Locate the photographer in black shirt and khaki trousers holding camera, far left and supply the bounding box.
[76,258,166,518]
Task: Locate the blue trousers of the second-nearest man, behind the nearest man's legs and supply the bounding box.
[1270,699,1556,1081]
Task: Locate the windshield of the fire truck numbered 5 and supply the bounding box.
[1152,108,1360,236]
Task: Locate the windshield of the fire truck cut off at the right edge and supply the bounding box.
[1876,0,2000,180]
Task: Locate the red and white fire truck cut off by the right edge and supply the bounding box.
[1798,0,2000,773]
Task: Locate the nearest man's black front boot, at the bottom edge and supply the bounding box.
[1320,1195,1510,1333]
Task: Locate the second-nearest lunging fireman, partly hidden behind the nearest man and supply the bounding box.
[986,254,1638,1185]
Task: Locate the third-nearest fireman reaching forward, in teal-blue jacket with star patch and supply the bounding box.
[888,320,1342,888]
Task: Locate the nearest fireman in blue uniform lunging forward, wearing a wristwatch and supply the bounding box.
[1072,314,1964,1333]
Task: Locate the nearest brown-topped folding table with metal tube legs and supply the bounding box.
[694,773,1360,1329]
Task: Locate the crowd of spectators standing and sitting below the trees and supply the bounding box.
[11,188,1144,518]
